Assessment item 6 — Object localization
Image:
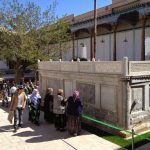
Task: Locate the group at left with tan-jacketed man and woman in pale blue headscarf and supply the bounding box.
[7,79,41,132]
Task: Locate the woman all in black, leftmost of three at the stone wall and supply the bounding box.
[44,88,54,123]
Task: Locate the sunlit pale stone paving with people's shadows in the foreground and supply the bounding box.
[0,100,126,150]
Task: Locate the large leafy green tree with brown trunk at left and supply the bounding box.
[0,0,70,82]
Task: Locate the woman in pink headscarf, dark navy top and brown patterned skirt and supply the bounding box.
[67,91,83,136]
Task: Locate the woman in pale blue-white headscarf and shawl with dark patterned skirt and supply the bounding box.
[29,89,41,126]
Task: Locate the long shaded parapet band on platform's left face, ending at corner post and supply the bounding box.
[38,61,122,74]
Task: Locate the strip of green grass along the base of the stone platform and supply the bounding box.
[82,124,150,150]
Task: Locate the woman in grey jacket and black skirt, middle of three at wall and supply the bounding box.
[53,89,67,131]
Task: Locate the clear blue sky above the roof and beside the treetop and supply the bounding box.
[14,0,112,17]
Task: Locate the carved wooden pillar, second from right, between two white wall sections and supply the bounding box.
[111,23,117,61]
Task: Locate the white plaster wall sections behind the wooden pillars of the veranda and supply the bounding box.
[65,27,150,61]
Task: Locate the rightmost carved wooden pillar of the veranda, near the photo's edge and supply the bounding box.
[141,16,146,60]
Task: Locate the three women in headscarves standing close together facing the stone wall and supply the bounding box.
[44,88,83,136]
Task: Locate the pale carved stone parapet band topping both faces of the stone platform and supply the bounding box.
[38,60,150,76]
